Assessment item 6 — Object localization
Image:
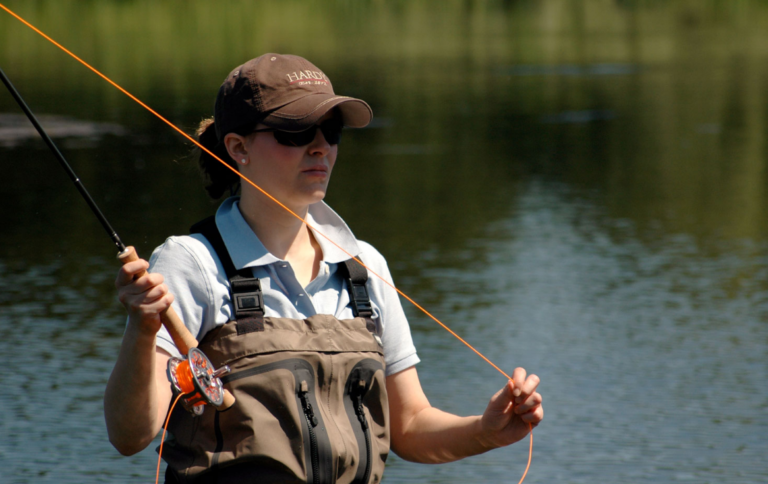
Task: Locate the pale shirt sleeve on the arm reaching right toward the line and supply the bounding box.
[358,241,420,376]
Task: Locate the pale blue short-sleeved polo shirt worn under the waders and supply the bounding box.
[149,197,419,375]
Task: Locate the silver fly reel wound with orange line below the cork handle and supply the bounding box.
[167,348,229,415]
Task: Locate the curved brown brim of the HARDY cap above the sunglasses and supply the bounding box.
[262,94,373,131]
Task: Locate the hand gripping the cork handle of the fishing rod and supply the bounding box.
[115,259,173,334]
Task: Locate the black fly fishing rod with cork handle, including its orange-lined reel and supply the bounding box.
[0,63,235,415]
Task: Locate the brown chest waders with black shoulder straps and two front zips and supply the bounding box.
[163,217,389,484]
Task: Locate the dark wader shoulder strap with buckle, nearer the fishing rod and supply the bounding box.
[189,216,264,334]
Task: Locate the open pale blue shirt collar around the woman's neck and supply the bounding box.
[216,197,360,270]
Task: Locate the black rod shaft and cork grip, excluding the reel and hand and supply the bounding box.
[0,64,235,410]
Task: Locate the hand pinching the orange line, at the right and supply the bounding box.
[481,368,544,448]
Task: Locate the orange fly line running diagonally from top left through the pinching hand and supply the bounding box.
[0,3,533,484]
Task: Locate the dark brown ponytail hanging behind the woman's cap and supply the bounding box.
[195,118,240,200]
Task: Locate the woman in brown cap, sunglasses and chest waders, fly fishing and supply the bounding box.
[104,54,543,482]
